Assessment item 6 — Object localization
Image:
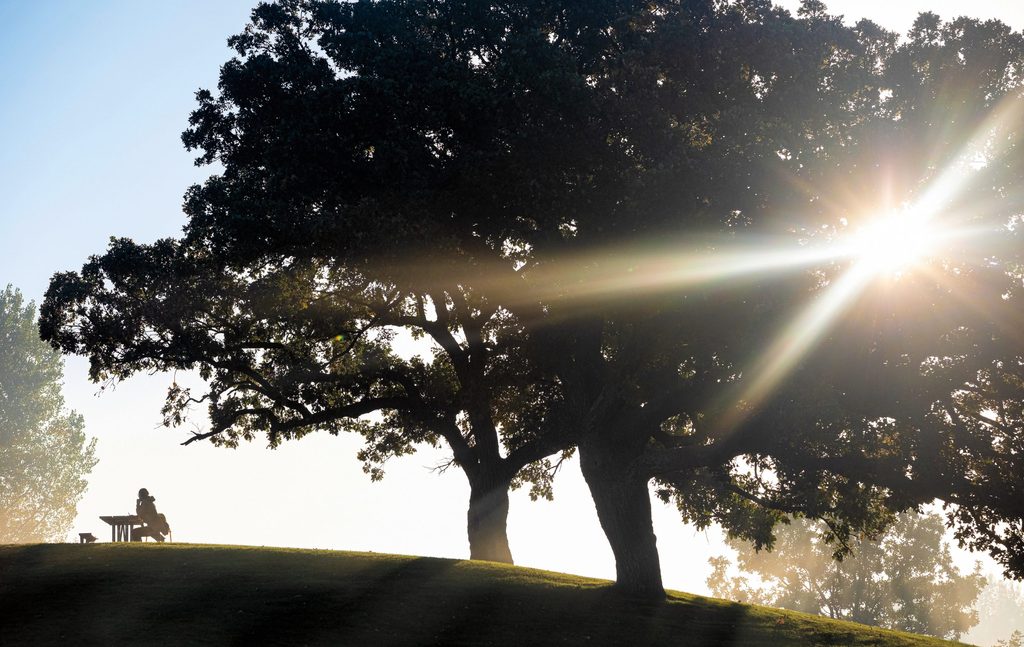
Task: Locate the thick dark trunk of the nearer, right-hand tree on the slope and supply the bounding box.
[580,444,665,600]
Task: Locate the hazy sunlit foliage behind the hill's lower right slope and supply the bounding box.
[708,513,985,640]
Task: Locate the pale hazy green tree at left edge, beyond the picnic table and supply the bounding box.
[0,286,96,544]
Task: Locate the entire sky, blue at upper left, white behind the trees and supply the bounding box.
[0,0,1024,618]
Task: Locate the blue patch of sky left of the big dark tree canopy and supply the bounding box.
[0,0,250,299]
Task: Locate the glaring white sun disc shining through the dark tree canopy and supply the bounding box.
[850,212,936,276]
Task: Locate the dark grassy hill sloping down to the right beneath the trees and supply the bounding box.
[0,543,948,647]
